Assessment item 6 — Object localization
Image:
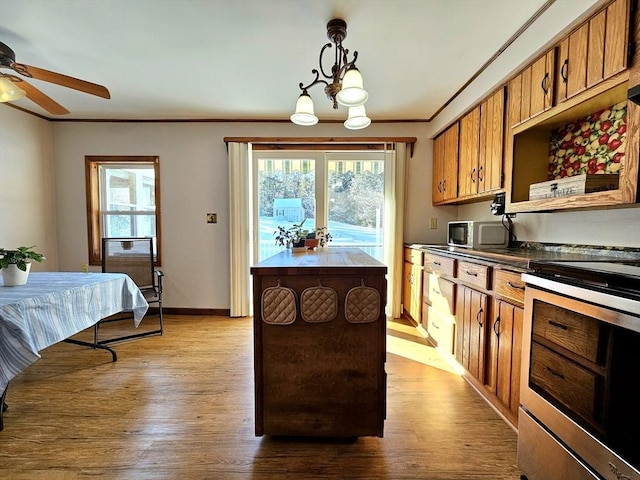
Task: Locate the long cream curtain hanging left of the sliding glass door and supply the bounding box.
[228,142,253,317]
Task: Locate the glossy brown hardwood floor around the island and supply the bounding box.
[0,315,519,480]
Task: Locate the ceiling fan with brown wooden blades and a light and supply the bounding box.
[0,42,111,115]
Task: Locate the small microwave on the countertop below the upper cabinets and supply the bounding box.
[447,221,509,250]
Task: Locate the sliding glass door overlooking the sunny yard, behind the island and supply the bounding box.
[253,150,390,261]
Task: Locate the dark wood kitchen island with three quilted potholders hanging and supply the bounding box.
[251,247,387,437]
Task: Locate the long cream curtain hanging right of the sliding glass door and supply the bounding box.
[384,143,408,318]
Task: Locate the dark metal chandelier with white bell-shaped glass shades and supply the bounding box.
[290,18,371,130]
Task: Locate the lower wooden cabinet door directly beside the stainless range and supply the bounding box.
[485,300,523,414]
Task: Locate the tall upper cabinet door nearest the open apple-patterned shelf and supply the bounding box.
[477,88,505,193]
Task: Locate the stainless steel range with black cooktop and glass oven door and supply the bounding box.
[518,260,640,480]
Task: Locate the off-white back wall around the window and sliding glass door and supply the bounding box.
[53,122,436,309]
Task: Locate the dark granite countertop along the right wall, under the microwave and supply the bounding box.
[406,242,640,271]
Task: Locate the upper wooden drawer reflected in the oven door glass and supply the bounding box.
[533,302,601,363]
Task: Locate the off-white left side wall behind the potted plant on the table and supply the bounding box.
[0,104,58,271]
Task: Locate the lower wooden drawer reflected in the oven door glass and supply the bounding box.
[530,342,603,423]
